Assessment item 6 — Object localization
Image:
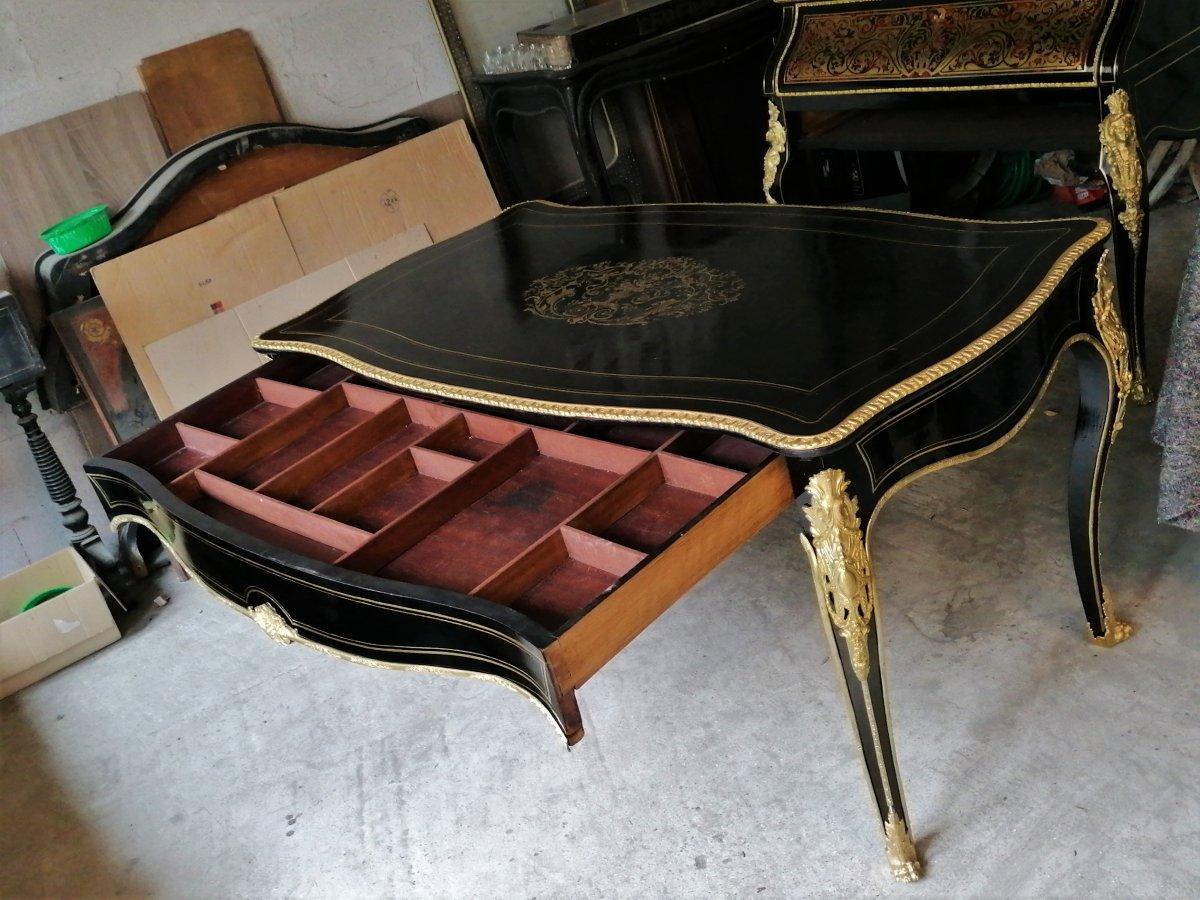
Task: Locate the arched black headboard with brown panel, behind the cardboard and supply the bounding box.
[35,115,428,420]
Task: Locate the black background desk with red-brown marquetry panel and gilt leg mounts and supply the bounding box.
[764,0,1200,402]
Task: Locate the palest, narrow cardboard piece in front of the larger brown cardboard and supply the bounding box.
[145,226,431,415]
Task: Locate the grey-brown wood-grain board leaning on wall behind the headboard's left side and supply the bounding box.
[0,94,167,329]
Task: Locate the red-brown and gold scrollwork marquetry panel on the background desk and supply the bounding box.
[775,0,1114,95]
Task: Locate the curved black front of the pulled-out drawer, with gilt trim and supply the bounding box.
[88,461,578,736]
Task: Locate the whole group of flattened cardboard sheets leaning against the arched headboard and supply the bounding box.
[92,121,499,415]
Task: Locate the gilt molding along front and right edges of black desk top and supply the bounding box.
[251,219,1110,452]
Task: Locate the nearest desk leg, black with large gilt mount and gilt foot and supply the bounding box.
[804,469,922,881]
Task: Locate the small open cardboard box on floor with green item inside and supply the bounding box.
[0,547,121,697]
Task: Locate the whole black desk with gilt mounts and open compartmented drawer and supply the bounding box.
[88,203,1132,880]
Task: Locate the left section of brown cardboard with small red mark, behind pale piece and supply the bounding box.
[91,197,304,415]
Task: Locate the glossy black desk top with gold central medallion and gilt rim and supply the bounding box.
[254,202,1109,454]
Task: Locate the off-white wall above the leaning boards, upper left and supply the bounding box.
[0,0,457,133]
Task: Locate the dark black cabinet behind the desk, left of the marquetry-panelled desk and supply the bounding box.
[473,0,779,204]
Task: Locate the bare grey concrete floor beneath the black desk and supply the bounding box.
[0,208,1200,898]
